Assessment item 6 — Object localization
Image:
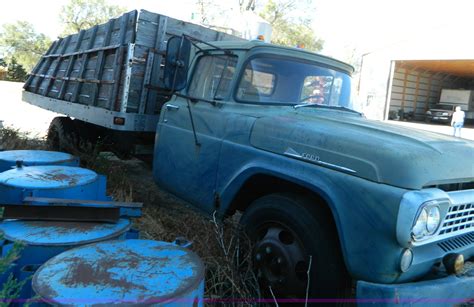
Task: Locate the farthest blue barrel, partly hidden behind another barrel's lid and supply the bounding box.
[0,150,79,172]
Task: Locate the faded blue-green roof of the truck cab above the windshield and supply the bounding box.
[198,40,354,74]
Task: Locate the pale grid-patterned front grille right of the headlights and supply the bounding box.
[439,203,474,235]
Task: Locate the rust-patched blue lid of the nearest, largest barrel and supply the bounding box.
[32,240,204,306]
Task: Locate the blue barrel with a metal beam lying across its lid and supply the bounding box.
[0,219,131,299]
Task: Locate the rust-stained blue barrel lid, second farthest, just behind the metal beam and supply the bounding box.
[0,165,97,189]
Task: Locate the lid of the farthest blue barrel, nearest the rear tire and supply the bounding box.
[0,150,76,165]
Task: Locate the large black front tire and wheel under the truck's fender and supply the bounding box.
[241,194,351,299]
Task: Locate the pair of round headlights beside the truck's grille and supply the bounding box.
[411,203,441,241]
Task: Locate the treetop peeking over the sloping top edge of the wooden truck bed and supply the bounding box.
[59,0,126,36]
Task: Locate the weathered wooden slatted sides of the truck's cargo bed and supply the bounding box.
[24,10,241,114]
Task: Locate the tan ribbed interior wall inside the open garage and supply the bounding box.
[390,63,471,120]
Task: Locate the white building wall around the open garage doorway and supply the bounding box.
[355,27,474,120]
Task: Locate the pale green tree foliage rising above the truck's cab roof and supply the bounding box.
[260,0,324,52]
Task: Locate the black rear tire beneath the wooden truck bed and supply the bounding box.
[46,117,77,153]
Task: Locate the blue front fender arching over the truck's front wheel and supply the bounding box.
[217,145,406,283]
